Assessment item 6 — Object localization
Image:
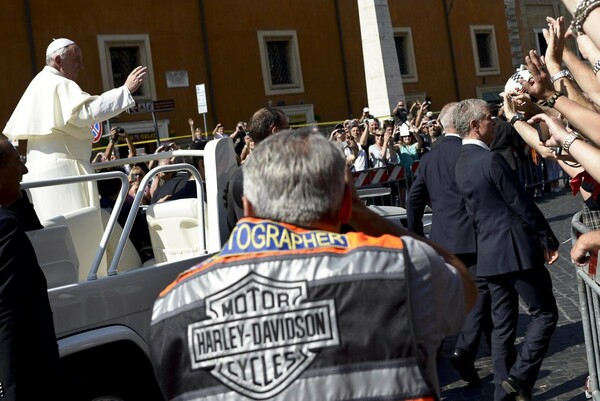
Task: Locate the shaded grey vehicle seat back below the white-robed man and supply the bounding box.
[27,225,79,288]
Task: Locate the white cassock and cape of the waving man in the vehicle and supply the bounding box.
[3,66,135,221]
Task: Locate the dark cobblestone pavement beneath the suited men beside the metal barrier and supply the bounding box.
[438,188,588,401]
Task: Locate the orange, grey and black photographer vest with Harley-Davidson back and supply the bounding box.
[150,218,436,401]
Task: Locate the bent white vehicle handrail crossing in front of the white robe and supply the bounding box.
[21,171,129,280]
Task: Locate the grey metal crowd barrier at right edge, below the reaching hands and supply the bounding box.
[571,212,600,401]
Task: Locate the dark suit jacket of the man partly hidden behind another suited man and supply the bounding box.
[406,136,477,253]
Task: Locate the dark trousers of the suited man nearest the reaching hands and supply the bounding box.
[486,266,558,401]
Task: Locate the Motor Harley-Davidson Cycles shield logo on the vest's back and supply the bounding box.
[187,273,339,399]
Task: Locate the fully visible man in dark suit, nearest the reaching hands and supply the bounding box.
[454,99,559,401]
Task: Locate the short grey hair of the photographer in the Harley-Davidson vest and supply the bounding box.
[242,129,346,226]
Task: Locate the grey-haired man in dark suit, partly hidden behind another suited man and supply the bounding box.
[406,103,491,385]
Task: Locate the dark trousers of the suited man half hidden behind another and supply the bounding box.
[455,253,492,358]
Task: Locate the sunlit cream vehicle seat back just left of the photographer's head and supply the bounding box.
[146,198,207,263]
